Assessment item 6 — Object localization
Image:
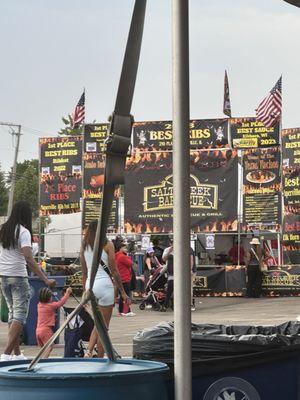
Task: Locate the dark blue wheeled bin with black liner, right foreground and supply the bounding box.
[133,322,300,400]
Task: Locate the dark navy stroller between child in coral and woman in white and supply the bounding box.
[63,296,94,358]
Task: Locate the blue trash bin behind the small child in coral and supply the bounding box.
[22,276,66,346]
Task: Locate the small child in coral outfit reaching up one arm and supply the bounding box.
[35,287,72,358]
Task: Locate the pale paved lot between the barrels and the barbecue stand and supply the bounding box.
[0,297,300,357]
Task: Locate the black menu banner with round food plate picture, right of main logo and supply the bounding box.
[243,147,281,230]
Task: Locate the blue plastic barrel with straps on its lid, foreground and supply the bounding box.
[0,358,168,400]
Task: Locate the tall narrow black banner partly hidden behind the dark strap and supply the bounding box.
[82,124,119,233]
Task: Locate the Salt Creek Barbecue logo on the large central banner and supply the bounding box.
[143,175,218,212]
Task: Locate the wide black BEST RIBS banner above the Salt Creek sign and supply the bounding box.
[133,118,228,151]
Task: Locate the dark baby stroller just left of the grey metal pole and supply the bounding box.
[139,265,167,311]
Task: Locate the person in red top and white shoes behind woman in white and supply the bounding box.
[116,243,135,317]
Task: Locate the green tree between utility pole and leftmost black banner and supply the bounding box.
[14,159,39,216]
